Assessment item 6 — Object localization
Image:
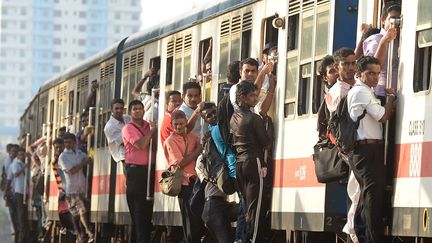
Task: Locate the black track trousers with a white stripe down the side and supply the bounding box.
[237,159,266,242]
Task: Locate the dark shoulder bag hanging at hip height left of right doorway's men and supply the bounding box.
[313,140,349,183]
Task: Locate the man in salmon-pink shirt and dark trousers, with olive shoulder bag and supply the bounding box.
[164,110,204,243]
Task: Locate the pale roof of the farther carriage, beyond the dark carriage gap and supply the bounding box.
[38,37,127,93]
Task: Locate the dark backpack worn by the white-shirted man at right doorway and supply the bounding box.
[328,96,366,155]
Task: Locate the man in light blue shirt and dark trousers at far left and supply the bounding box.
[6,148,29,243]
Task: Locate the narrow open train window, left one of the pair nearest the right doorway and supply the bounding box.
[297,63,311,116]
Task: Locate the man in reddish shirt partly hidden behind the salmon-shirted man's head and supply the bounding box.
[160,90,183,146]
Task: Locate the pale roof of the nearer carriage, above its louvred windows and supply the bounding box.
[123,0,258,52]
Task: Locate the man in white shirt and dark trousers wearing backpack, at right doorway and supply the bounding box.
[347,56,396,242]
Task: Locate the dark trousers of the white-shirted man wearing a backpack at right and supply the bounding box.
[350,144,385,243]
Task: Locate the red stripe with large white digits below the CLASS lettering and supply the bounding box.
[395,142,432,178]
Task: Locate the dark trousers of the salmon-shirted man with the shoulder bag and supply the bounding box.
[178,183,204,243]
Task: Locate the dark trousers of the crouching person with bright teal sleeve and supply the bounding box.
[202,197,238,243]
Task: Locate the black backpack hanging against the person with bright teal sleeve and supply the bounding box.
[202,135,236,195]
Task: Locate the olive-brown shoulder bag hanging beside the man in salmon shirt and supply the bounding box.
[159,166,183,197]
